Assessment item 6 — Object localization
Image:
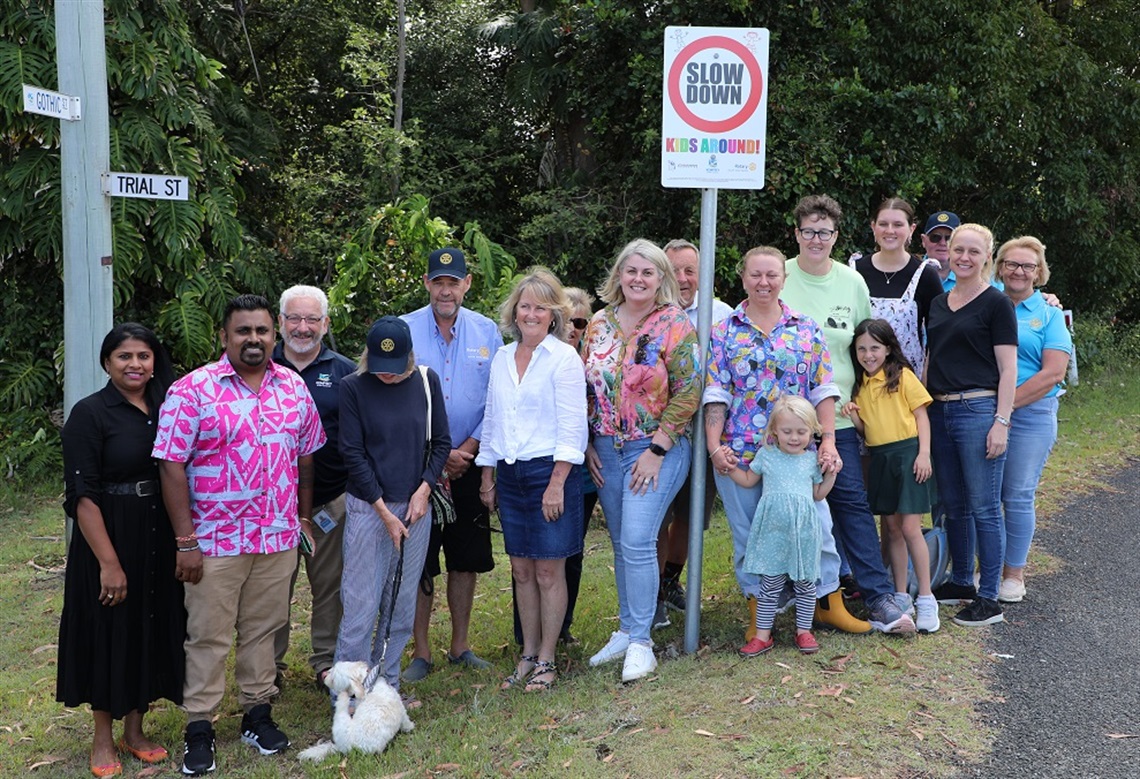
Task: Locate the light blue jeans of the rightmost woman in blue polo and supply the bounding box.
[1001,397,1057,568]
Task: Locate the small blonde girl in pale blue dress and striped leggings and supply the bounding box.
[728,395,836,657]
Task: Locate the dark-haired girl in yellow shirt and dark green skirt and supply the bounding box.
[840,319,939,633]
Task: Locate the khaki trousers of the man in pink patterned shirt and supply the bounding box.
[182,549,296,722]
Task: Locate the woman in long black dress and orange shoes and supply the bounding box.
[56,323,185,777]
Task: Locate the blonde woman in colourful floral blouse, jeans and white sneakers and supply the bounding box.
[584,238,701,682]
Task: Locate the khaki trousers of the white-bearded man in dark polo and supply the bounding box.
[274,495,344,673]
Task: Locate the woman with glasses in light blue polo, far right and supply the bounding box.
[996,236,1073,603]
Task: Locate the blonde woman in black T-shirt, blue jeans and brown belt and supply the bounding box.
[926,224,1018,627]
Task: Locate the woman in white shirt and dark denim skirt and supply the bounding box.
[475,268,587,692]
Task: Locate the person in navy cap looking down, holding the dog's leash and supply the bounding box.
[336,316,451,689]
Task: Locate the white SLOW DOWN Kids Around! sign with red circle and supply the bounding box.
[661,27,768,189]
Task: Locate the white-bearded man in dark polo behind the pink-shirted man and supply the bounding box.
[274,284,356,691]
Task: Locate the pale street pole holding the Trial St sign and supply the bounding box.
[56,0,113,414]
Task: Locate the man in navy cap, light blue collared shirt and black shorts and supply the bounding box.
[404,249,503,682]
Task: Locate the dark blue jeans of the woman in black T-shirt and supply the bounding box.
[930,397,1005,600]
